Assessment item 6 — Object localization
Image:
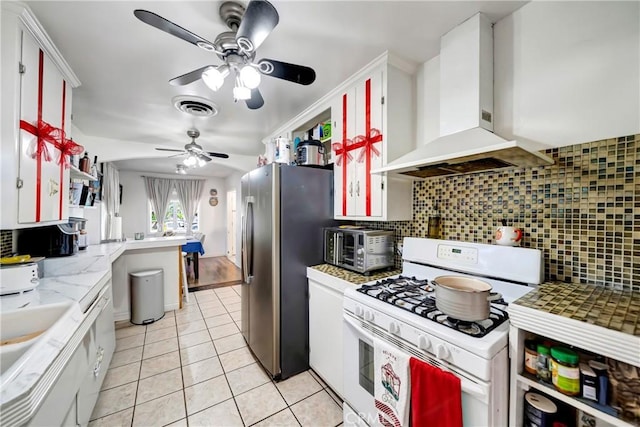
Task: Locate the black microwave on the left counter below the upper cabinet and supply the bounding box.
[18,223,78,258]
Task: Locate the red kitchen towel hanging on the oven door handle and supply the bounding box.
[409,357,462,427]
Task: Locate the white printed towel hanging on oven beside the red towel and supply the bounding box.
[373,337,411,427]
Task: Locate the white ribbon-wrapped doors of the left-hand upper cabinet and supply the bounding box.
[18,31,71,223]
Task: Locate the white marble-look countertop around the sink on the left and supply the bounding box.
[0,236,186,422]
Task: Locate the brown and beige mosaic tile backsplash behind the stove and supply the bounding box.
[358,135,640,291]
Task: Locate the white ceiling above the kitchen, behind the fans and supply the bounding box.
[26,0,526,177]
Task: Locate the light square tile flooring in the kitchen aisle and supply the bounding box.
[89,286,342,427]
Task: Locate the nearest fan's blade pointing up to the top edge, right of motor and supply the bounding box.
[236,0,280,52]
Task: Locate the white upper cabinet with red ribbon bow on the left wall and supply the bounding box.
[0,2,79,229]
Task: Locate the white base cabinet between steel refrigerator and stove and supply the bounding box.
[307,268,352,397]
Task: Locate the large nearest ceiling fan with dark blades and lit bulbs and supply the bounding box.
[133,0,316,110]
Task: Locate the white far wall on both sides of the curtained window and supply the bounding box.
[120,171,227,257]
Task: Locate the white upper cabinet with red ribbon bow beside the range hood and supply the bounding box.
[331,61,415,221]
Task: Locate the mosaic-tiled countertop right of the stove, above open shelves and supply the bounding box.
[513,282,640,336]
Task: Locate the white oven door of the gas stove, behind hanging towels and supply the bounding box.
[343,312,492,426]
